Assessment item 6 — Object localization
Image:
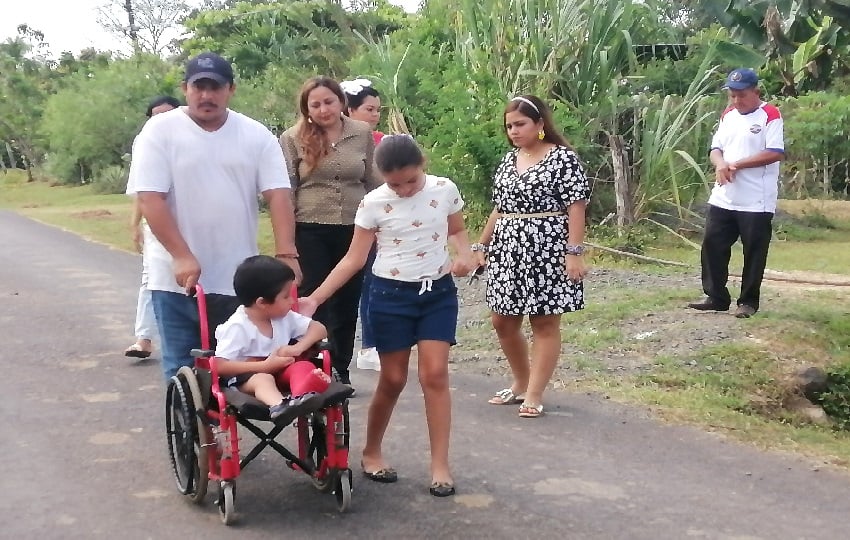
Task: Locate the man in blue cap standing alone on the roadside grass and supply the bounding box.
[688,68,785,318]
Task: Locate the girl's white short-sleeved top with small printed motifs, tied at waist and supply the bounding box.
[354,175,463,282]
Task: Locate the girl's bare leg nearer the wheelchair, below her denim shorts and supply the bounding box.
[363,349,410,472]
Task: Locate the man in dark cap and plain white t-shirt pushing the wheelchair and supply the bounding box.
[129,52,301,380]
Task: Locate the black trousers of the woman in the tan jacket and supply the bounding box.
[295,223,363,377]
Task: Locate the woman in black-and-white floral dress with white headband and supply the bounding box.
[472,95,590,418]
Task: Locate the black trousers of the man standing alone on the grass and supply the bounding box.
[701,205,773,310]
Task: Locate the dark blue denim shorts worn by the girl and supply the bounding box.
[369,274,458,352]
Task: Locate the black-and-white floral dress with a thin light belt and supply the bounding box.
[486,146,590,315]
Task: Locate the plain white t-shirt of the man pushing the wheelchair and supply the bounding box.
[127,107,290,295]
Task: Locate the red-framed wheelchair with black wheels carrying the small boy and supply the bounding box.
[165,285,352,525]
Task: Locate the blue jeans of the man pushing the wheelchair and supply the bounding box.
[151,291,239,382]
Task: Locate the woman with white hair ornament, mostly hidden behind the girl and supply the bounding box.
[340,79,384,371]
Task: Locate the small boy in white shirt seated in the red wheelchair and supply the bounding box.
[215,255,354,423]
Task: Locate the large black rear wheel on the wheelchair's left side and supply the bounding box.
[165,373,208,503]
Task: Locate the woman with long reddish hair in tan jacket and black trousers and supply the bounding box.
[278,77,379,384]
